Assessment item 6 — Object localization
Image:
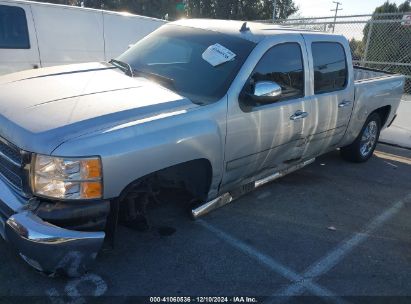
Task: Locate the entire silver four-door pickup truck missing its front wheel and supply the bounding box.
[0,20,404,276]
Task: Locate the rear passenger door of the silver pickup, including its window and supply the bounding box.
[304,34,354,157]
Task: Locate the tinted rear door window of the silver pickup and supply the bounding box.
[312,42,348,94]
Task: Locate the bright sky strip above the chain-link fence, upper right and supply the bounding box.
[294,0,410,17]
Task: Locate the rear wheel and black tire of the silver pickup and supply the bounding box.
[340,113,381,163]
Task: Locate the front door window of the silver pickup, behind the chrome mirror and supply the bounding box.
[253,43,304,100]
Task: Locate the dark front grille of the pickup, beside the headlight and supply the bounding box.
[0,138,24,191]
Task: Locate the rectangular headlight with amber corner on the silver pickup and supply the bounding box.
[32,155,103,200]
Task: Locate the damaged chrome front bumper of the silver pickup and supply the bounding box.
[0,179,105,277]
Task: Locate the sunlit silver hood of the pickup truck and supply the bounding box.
[0,63,197,154]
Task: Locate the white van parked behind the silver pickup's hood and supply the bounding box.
[0,0,165,75]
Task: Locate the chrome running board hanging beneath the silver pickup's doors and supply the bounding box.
[191,158,315,219]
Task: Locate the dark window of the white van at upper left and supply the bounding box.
[0,5,30,49]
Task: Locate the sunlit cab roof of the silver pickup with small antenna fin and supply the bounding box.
[169,19,338,43]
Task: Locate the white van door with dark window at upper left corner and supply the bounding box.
[0,1,40,75]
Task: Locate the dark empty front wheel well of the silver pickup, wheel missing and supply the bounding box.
[106,159,213,238]
